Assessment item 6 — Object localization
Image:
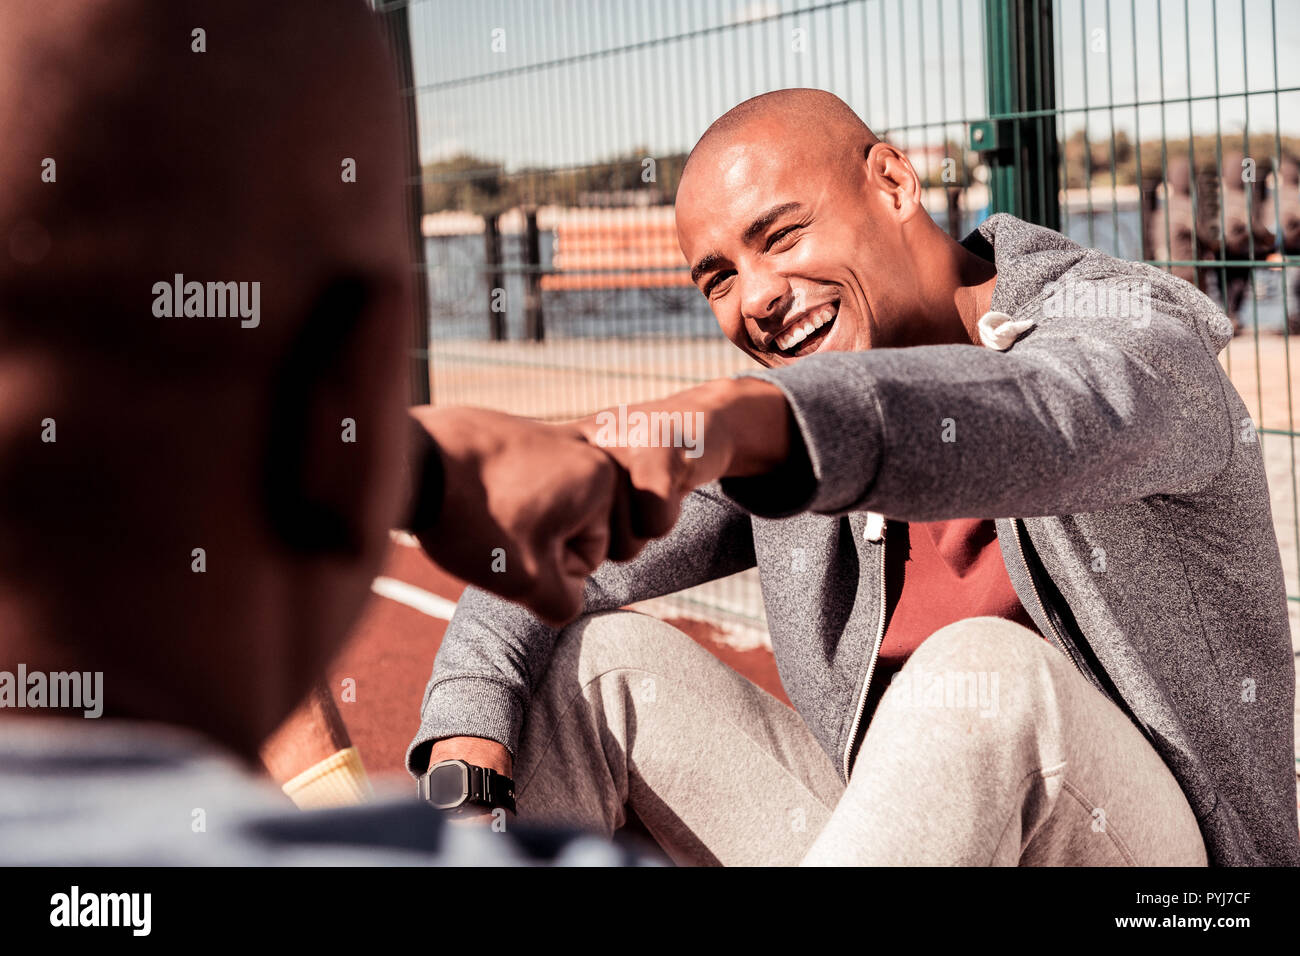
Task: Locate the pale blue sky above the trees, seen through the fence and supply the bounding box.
[410,0,1300,169]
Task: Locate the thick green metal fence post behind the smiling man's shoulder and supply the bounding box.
[970,0,1061,229]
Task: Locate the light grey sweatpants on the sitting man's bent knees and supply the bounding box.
[515,611,1205,866]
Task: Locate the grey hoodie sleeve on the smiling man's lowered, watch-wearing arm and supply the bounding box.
[407,484,754,775]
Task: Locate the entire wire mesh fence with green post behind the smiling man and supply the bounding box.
[387,0,1300,640]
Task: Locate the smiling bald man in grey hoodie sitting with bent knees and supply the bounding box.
[408,90,1300,865]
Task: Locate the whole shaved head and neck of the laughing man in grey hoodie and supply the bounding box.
[676,90,977,365]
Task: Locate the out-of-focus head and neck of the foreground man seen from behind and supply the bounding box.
[0,0,411,756]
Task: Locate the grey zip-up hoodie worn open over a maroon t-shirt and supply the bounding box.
[407,213,1300,865]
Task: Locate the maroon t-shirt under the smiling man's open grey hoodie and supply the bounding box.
[863,518,1037,721]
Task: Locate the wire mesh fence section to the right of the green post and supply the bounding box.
[1053,0,1300,635]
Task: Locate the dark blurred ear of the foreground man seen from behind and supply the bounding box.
[263,277,381,558]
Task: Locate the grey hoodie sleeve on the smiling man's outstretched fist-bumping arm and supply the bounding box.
[722,286,1237,522]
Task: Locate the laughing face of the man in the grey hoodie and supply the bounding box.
[676,94,925,367]
